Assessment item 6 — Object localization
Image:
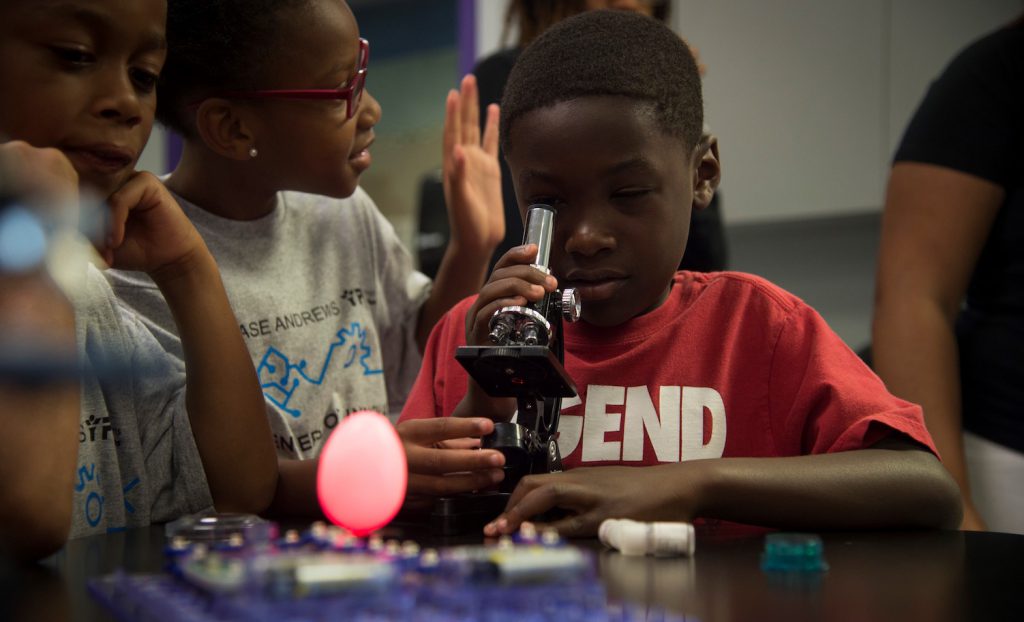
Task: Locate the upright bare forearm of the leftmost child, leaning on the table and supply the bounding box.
[152,247,278,512]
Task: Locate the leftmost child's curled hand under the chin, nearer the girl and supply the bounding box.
[97,172,209,279]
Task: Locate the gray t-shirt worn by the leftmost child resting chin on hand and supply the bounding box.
[69,264,213,538]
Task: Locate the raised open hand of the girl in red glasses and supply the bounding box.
[442,75,505,259]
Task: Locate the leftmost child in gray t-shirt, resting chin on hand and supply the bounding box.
[0,0,276,558]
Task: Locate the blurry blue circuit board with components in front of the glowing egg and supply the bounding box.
[89,524,685,622]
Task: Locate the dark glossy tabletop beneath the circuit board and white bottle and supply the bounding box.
[0,526,1024,622]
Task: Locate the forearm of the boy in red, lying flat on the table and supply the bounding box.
[676,445,962,530]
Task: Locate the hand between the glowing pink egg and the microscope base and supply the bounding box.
[396,417,505,497]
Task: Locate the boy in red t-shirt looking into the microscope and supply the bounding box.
[402,11,961,536]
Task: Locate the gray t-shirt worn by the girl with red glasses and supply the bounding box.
[108,189,430,459]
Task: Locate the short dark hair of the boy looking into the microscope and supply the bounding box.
[501,10,703,153]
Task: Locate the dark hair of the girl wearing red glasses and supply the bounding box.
[157,0,309,136]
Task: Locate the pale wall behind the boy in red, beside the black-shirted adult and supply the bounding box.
[476,0,1024,222]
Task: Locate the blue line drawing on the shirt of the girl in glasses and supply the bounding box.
[256,322,383,418]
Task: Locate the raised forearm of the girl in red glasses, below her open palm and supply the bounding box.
[416,244,494,353]
